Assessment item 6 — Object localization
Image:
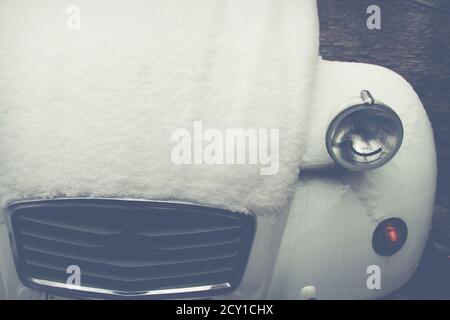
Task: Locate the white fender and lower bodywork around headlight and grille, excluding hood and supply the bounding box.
[0,60,436,299]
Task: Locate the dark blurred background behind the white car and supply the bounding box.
[318,0,450,299]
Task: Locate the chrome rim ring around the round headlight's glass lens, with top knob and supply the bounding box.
[325,91,404,172]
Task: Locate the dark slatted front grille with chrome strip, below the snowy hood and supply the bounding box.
[9,199,255,298]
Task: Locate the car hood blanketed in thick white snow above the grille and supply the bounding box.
[0,0,319,215]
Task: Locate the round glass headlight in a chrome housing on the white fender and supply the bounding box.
[326,91,403,171]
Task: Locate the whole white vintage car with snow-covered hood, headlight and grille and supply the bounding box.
[0,0,436,299]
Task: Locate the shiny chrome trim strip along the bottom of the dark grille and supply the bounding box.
[28,278,231,297]
